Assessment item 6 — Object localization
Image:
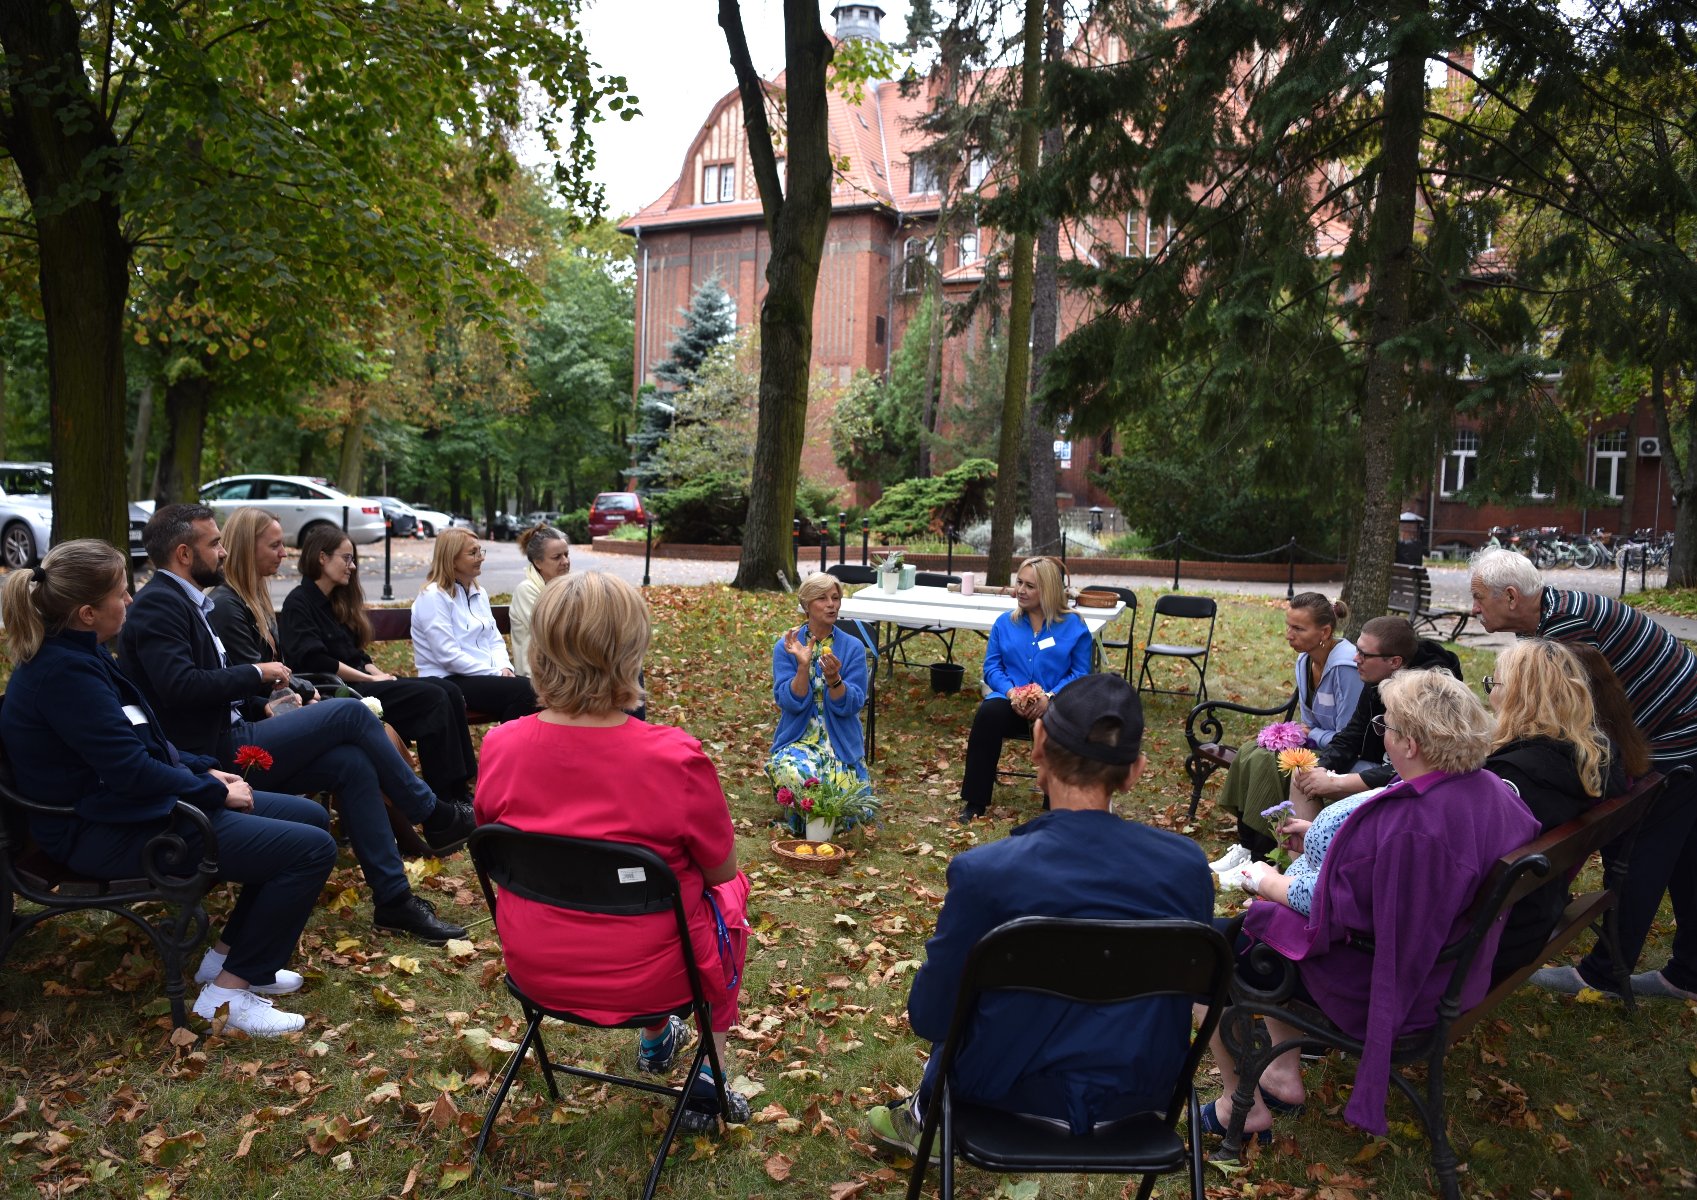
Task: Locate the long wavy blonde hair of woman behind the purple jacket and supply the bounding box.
[1490,638,1609,796]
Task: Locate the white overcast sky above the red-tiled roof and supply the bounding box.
[582,0,908,217]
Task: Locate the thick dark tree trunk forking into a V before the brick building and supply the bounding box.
[720,0,832,591]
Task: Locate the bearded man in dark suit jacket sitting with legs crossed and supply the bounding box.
[119,504,475,944]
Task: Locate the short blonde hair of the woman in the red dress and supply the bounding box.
[528,570,650,716]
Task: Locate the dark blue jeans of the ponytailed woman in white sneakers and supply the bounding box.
[66,791,336,983]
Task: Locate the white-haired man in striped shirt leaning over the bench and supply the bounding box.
[1470,550,1697,1000]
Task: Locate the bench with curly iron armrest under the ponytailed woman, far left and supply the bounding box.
[0,702,217,1027]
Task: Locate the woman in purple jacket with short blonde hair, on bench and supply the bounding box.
[1201,670,1537,1141]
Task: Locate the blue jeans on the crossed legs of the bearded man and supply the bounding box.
[231,699,436,905]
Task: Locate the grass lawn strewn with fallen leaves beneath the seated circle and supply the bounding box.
[0,587,1697,1200]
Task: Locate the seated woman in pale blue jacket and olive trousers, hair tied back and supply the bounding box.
[1208,592,1361,876]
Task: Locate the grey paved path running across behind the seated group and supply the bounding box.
[251,541,1697,648]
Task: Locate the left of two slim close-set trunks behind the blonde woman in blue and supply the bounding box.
[986,0,1054,582]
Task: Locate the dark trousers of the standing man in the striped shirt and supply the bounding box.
[1580,762,1697,991]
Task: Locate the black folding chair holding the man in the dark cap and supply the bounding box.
[908,917,1232,1200]
